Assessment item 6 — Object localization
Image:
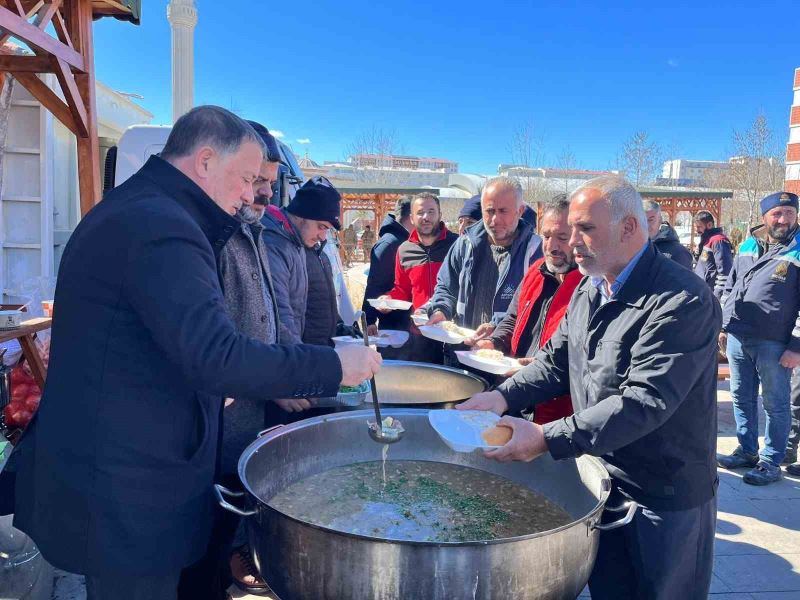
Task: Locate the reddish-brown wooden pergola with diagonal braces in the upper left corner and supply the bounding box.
[0,0,140,215]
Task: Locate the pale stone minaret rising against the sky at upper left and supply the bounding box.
[167,0,197,123]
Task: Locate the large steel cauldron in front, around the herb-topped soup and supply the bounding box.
[216,409,636,600]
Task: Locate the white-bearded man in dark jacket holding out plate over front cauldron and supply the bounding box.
[459,177,721,600]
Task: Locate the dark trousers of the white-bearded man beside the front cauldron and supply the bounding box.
[589,492,717,600]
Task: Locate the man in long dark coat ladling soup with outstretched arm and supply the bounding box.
[8,107,380,600]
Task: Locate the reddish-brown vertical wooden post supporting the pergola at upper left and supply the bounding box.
[68,0,101,216]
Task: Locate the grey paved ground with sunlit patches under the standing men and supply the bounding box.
[53,383,800,600]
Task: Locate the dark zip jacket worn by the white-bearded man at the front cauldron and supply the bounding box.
[498,245,722,510]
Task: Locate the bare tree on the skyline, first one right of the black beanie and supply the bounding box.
[346,125,402,184]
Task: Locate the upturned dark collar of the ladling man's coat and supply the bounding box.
[139,155,240,254]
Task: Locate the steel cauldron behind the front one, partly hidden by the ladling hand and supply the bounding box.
[359,360,489,408]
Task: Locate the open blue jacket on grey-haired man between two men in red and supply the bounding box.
[428,219,543,327]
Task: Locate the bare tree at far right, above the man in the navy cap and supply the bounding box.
[720,113,786,227]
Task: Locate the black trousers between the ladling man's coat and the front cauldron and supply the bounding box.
[179,475,243,600]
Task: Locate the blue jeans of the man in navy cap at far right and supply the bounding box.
[727,334,792,466]
